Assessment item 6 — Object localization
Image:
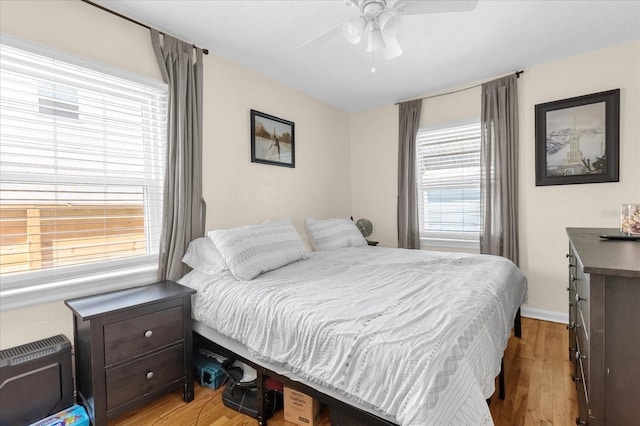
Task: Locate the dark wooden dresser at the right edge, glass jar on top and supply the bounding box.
[567,228,640,426]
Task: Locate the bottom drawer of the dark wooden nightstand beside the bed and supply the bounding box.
[106,344,185,411]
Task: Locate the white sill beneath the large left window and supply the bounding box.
[0,265,158,312]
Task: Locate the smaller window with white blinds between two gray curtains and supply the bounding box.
[416,121,480,249]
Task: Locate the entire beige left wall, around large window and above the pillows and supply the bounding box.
[0,0,351,348]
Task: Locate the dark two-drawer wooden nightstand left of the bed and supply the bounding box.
[65,281,195,426]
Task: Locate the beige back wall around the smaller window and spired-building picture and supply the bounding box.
[351,42,640,316]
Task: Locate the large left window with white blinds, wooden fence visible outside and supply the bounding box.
[0,35,167,309]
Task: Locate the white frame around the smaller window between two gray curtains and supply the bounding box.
[416,117,482,253]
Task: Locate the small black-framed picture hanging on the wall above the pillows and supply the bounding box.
[251,110,296,167]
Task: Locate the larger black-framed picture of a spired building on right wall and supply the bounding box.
[536,89,620,186]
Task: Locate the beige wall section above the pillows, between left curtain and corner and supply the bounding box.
[203,59,351,232]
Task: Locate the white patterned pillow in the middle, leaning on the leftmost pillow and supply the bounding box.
[208,219,307,280]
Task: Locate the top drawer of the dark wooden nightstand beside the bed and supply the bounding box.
[104,306,183,366]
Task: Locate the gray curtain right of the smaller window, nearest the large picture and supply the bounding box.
[480,74,519,265]
